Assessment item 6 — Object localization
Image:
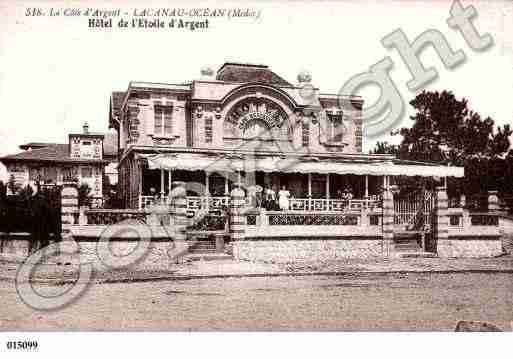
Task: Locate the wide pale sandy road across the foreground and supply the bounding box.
[0,272,513,331]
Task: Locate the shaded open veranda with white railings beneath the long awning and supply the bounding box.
[138,169,386,212]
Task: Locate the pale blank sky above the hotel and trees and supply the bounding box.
[0,0,513,180]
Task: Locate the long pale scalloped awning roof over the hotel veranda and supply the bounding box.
[140,153,464,177]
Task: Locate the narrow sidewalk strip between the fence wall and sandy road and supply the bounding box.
[0,255,513,283]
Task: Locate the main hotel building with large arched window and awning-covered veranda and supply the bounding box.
[109,63,463,210]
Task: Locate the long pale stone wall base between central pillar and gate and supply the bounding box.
[232,238,383,263]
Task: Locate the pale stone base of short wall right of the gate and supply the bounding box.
[437,237,503,258]
